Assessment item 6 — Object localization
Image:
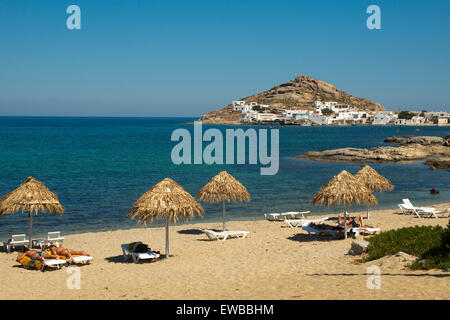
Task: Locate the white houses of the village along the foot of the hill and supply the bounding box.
[232,101,450,125]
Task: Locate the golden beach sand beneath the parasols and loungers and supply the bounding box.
[0,204,450,299]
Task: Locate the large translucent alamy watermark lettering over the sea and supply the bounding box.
[170,121,279,175]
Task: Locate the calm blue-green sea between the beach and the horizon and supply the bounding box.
[0,117,450,240]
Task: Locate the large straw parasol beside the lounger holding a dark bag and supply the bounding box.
[128,178,204,258]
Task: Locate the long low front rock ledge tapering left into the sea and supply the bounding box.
[297,147,430,162]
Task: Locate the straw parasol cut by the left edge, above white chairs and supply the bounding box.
[0,177,64,248]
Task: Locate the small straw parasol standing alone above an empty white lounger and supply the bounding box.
[197,171,250,231]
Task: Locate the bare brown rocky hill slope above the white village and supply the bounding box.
[200,75,385,123]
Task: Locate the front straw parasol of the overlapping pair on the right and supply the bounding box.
[311,170,377,238]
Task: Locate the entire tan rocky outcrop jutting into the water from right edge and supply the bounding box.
[297,134,450,171]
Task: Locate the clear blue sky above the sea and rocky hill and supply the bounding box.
[0,0,450,116]
